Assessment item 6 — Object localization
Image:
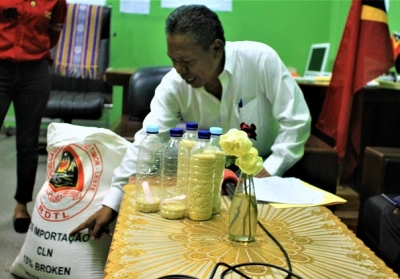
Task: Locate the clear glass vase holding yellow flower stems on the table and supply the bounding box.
[229,173,258,242]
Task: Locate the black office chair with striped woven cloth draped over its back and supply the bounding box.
[44,4,112,123]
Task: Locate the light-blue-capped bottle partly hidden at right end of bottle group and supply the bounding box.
[210,127,226,214]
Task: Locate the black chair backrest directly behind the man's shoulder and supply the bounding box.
[128,66,172,121]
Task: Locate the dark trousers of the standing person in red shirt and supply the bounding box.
[0,59,50,203]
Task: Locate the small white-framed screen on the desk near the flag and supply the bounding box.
[304,43,330,76]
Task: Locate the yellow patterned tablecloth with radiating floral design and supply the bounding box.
[104,185,398,279]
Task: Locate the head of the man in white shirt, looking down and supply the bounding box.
[165,5,225,88]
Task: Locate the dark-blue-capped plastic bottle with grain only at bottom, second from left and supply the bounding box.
[160,128,189,219]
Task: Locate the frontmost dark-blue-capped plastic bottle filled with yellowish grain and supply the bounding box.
[187,130,215,221]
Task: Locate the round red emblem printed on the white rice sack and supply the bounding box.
[36,144,103,221]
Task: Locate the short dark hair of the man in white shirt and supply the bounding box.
[165,5,225,50]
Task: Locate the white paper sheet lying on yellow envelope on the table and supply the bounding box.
[254,176,325,204]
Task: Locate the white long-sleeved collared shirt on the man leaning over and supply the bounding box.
[103,41,311,211]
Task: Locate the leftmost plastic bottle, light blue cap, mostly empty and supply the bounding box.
[136,125,164,212]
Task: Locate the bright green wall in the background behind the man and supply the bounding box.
[3,0,400,129]
